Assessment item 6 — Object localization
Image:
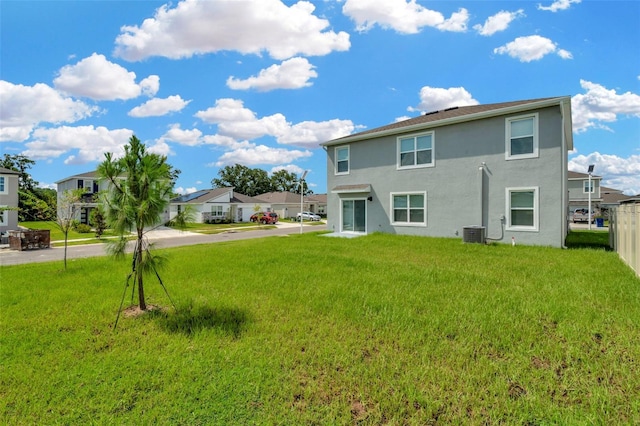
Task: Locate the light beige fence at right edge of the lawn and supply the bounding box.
[609,199,640,276]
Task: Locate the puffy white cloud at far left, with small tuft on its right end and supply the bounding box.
[53,53,160,101]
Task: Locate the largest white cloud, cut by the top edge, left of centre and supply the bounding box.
[114,0,350,61]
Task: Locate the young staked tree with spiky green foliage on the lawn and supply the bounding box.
[98,136,173,312]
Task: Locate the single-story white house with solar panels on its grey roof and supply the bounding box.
[169,188,267,223]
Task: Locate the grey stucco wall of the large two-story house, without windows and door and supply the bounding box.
[327,107,567,247]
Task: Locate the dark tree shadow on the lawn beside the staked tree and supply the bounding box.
[153,304,249,339]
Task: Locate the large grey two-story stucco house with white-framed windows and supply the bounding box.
[323,96,573,247]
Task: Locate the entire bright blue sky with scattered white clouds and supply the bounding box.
[0,0,640,194]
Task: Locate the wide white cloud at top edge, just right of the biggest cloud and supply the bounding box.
[342,0,469,34]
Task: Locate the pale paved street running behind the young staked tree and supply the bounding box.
[0,223,327,266]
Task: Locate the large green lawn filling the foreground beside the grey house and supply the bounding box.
[0,234,640,425]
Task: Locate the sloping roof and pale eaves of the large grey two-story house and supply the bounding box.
[321,96,573,149]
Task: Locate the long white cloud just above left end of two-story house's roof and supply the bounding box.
[195,98,355,148]
